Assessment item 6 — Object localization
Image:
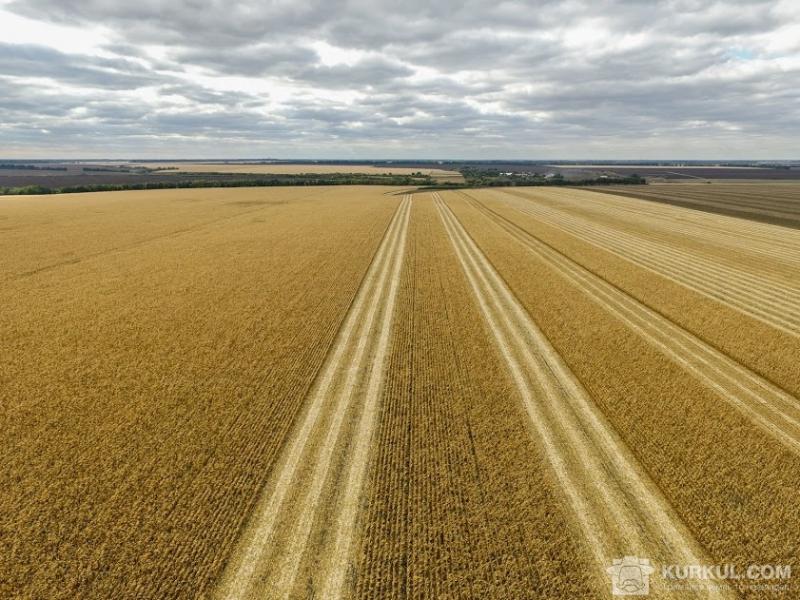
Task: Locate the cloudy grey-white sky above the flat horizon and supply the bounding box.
[0,0,800,160]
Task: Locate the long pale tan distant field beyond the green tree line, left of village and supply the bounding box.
[137,162,461,179]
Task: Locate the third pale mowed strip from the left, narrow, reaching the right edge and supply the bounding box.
[465,194,800,454]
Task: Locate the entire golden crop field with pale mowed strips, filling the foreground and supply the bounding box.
[0,183,800,600]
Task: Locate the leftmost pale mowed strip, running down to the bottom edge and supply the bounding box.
[218,196,411,599]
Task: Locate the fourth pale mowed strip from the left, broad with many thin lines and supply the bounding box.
[498,192,800,336]
